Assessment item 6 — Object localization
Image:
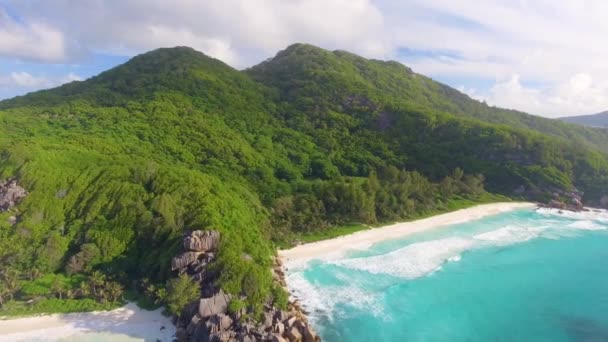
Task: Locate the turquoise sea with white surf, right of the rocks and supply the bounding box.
[287,209,608,342]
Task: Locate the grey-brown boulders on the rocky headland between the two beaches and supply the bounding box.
[171,230,320,342]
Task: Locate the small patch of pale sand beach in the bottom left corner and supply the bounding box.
[0,303,175,342]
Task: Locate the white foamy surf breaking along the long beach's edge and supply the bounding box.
[287,209,608,324]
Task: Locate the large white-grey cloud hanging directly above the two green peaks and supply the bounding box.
[4,0,390,67]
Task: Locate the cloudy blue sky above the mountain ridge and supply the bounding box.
[0,0,608,117]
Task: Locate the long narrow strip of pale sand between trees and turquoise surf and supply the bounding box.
[279,202,536,263]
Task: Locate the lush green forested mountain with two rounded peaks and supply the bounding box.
[0,44,608,316]
